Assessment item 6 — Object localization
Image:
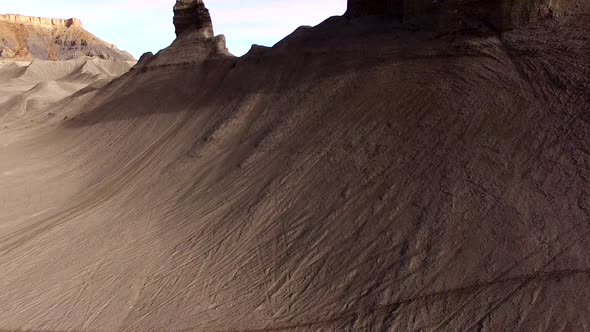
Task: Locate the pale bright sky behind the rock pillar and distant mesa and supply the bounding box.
[0,0,346,58]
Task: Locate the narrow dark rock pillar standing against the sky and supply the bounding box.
[174,0,214,38]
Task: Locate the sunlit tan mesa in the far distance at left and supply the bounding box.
[0,14,134,61]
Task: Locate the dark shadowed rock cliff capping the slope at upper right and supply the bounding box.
[346,0,590,31]
